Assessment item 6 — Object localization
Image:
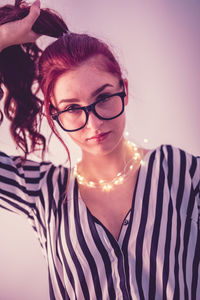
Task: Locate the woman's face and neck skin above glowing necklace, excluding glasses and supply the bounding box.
[53,56,128,179]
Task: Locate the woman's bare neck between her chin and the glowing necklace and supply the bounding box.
[78,139,137,181]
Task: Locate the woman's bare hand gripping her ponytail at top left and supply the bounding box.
[0,0,40,50]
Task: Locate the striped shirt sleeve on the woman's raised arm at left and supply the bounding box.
[0,152,50,217]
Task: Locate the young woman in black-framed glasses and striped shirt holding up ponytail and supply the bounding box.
[0,1,200,300]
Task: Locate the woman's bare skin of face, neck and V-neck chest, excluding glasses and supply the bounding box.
[52,56,146,239]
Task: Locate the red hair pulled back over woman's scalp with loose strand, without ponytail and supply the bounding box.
[39,32,122,164]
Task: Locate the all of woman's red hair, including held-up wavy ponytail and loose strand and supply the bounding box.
[0,0,122,163]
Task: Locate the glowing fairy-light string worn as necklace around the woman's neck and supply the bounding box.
[74,141,144,192]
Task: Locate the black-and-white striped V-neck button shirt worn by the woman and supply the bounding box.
[0,145,200,300]
